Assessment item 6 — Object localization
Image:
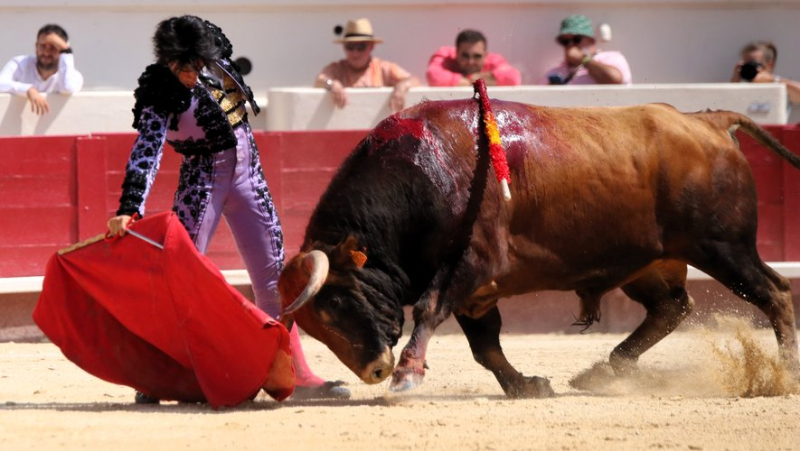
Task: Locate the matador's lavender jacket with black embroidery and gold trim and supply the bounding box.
[117,22,260,216]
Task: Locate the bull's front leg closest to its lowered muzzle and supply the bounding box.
[389,271,452,391]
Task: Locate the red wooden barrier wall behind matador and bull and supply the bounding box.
[0,127,800,277]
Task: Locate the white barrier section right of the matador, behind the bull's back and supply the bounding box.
[267,83,787,130]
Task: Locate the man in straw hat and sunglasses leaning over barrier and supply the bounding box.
[314,19,419,111]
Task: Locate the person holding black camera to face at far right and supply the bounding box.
[731,41,800,104]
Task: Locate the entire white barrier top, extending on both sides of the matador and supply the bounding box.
[0,83,787,136]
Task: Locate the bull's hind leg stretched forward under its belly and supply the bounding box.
[609,261,694,374]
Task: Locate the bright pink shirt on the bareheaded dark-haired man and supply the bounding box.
[425,47,521,86]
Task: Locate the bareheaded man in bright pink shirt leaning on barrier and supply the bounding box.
[425,30,521,86]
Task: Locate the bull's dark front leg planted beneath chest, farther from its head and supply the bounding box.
[455,306,554,398]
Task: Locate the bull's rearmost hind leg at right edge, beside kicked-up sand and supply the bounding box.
[692,244,800,374]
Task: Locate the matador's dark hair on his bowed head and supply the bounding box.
[153,16,223,66]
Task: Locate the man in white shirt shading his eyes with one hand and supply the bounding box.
[0,24,83,115]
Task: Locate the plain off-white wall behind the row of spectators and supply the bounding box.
[0,0,800,93]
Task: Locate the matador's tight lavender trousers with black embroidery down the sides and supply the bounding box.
[173,123,284,317]
